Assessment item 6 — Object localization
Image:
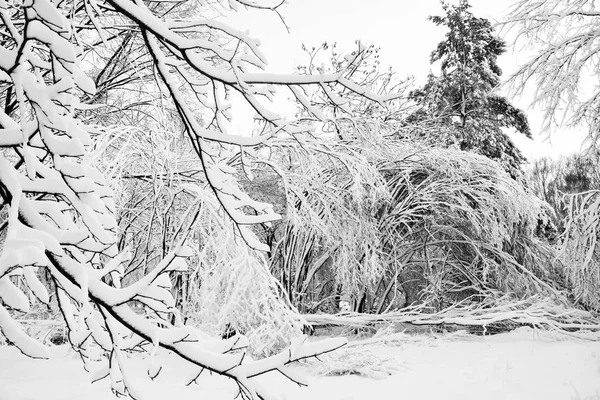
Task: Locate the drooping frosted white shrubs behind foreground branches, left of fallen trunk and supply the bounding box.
[92,127,304,357]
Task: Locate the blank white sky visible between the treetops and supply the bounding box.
[226,0,585,160]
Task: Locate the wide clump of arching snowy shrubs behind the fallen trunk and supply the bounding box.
[272,130,561,312]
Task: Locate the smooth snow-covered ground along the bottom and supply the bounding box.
[0,328,600,400]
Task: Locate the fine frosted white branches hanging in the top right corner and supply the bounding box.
[504,0,600,135]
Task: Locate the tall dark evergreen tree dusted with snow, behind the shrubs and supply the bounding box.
[409,0,531,178]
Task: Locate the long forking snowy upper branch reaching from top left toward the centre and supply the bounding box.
[92,0,404,234]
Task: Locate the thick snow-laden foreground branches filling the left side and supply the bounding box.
[0,0,370,399]
